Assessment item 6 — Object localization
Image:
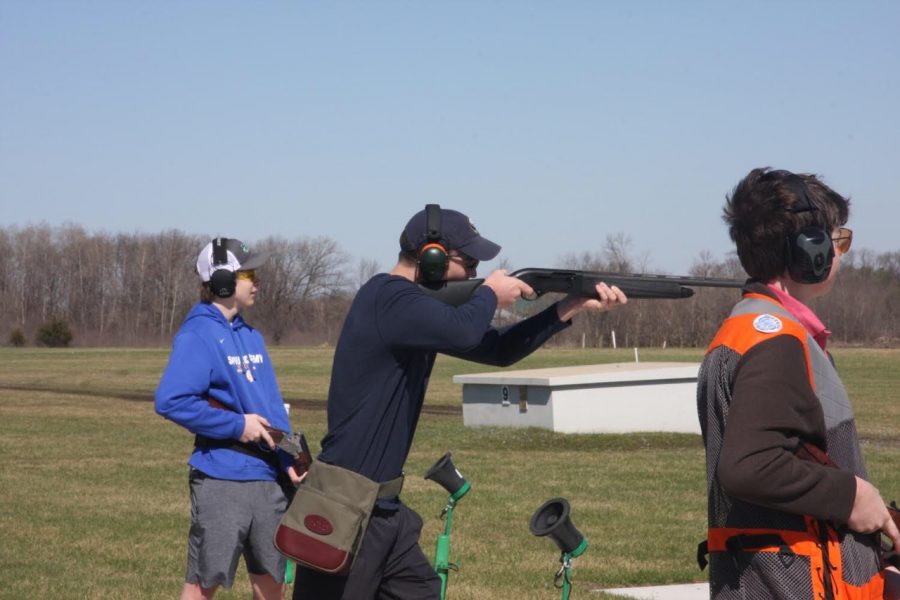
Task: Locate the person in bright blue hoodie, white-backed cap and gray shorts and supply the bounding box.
[155,238,301,600]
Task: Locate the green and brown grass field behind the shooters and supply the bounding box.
[0,348,900,600]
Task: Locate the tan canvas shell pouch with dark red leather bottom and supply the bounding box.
[275,461,390,575]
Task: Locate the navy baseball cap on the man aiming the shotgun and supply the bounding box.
[400,208,500,261]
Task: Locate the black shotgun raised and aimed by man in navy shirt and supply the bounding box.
[419,268,744,306]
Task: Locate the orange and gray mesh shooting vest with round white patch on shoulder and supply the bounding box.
[697,293,884,600]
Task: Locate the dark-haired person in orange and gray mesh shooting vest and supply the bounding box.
[697,169,900,600]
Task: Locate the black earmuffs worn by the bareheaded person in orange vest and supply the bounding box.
[774,171,834,283]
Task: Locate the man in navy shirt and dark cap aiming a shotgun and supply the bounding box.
[286,205,627,600]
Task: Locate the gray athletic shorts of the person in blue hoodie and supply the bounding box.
[185,469,287,588]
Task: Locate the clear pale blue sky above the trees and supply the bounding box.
[0,0,900,273]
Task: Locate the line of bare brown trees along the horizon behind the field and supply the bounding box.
[0,225,900,347]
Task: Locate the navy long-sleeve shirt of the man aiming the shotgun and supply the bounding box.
[319,273,568,505]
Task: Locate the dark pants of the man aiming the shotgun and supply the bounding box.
[293,504,441,600]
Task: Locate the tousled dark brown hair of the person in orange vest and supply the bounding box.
[722,167,850,282]
